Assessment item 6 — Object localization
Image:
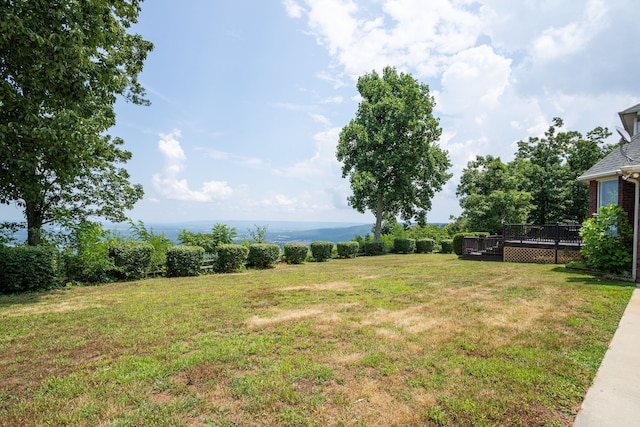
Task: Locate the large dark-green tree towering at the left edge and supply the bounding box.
[0,0,153,245]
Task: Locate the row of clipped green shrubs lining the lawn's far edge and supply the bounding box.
[0,233,464,293]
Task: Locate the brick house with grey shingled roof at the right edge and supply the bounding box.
[578,104,640,282]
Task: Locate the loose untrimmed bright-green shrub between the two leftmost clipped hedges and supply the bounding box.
[63,221,116,283]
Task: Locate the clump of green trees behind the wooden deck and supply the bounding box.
[456,117,612,229]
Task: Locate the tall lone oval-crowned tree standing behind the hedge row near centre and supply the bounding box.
[337,67,451,239]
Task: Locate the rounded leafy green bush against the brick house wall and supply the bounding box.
[580,205,633,273]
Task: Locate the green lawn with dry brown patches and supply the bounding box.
[0,254,635,426]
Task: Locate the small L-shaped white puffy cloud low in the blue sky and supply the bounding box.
[151,130,233,202]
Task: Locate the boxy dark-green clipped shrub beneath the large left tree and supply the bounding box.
[0,246,58,294]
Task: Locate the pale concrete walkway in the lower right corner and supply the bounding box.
[574,289,640,427]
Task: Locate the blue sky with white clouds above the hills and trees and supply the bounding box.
[0,0,640,227]
